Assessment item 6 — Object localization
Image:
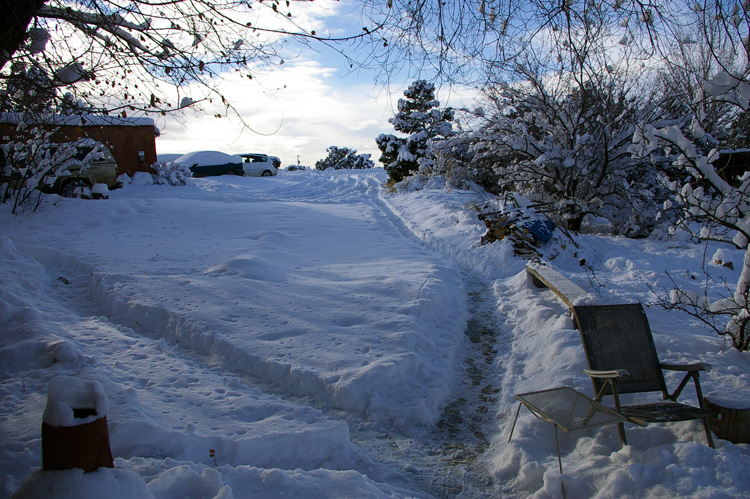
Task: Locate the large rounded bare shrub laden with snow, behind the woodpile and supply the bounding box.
[472,72,666,237]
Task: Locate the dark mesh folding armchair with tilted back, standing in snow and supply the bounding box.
[573,303,715,447]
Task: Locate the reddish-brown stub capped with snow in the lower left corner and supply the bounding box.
[42,376,114,472]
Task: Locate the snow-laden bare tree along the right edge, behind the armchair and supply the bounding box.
[632,2,750,350]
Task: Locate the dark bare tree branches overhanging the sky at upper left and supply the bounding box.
[0,0,377,119]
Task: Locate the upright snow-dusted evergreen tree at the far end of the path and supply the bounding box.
[375,80,454,182]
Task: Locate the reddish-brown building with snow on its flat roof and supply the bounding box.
[0,113,159,177]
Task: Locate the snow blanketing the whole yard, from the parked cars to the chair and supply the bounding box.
[0,169,750,499]
